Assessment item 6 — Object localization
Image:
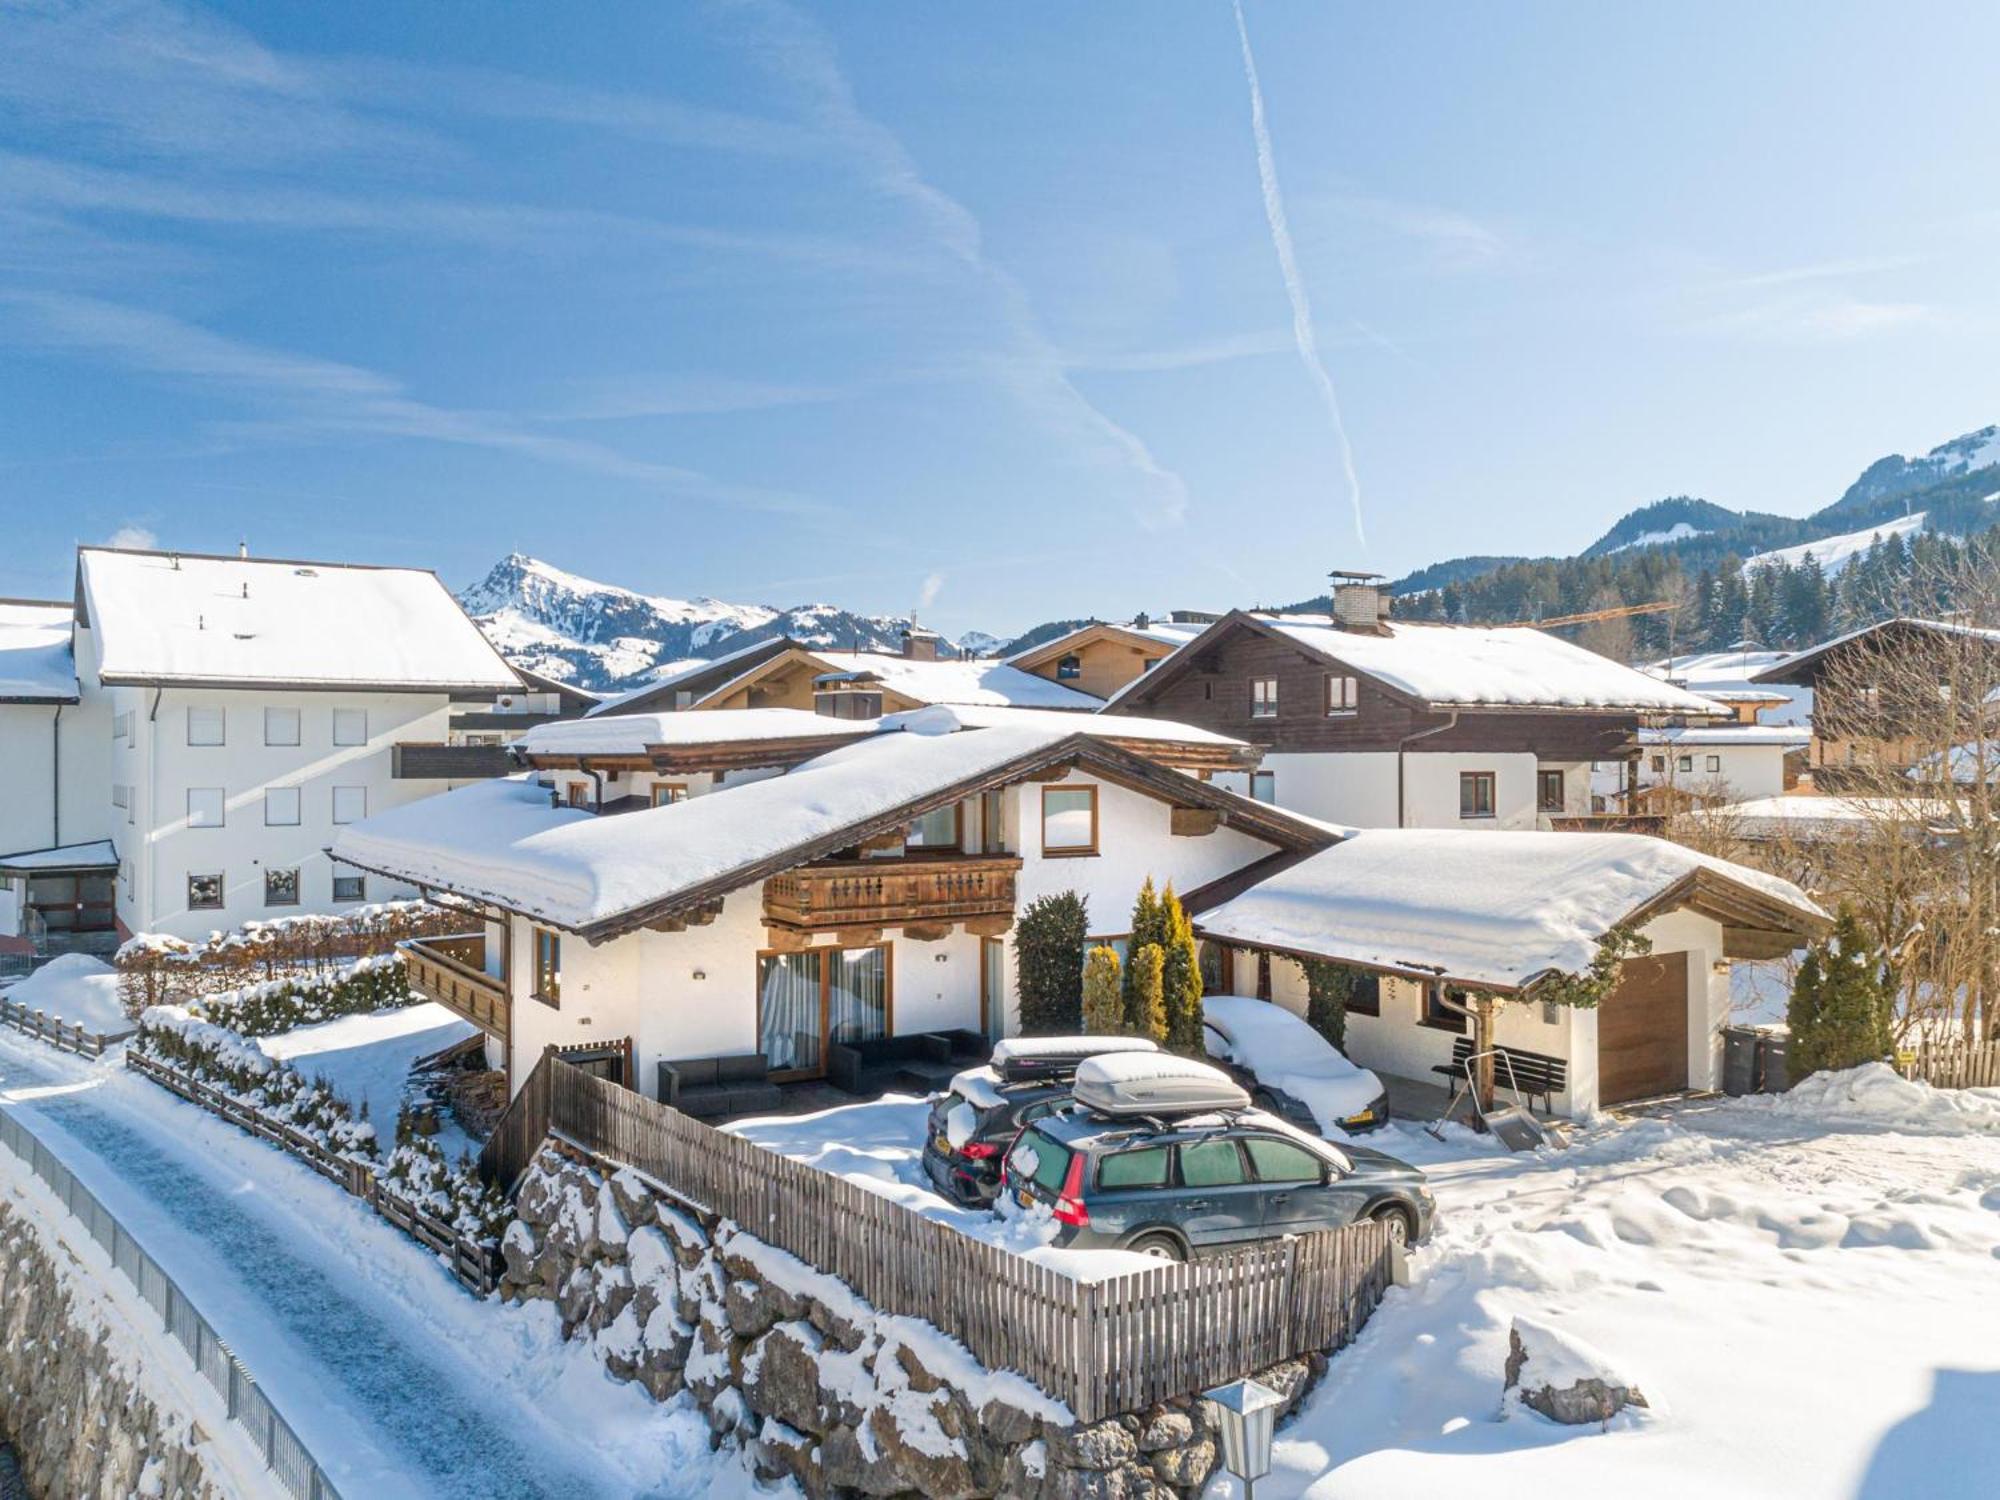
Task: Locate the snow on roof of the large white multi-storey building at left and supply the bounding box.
[76,548,520,692]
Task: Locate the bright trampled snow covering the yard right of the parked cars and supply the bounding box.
[1210,1070,2000,1500]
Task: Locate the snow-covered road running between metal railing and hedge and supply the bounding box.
[0,1032,772,1500]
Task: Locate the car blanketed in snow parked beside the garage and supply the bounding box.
[1202,994,1388,1136]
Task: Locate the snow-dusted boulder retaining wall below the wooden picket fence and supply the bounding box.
[500,1146,1324,1500]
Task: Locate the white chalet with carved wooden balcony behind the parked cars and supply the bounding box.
[334,708,1336,1092]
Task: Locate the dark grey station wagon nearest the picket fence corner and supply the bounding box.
[1002,1106,1436,1260]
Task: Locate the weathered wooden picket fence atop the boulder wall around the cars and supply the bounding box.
[508,1056,1396,1422]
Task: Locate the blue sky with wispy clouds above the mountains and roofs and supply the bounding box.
[0,0,2000,632]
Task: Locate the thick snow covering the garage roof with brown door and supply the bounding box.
[1196,828,1824,990]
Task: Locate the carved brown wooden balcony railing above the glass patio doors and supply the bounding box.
[764,854,1020,930]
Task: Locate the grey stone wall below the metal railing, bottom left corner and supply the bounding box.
[0,1204,216,1500]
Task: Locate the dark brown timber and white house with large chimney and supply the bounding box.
[1106,576,1726,830]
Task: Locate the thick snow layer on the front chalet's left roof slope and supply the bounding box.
[332,728,1104,930]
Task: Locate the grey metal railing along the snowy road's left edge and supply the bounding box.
[0,1110,340,1500]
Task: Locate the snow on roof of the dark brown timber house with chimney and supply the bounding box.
[1268,616,1720,716]
